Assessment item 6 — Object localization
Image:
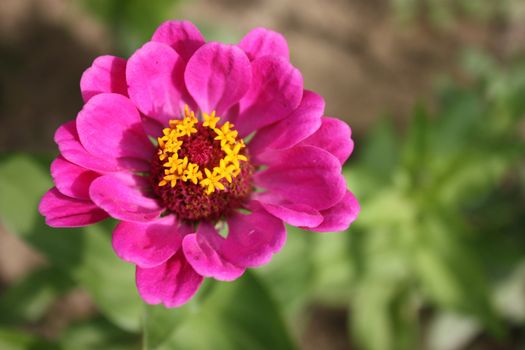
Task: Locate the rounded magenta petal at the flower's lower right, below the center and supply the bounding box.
[222,209,286,267]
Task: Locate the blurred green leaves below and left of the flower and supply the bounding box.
[0,155,295,349]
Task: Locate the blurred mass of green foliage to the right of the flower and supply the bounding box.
[259,52,525,350]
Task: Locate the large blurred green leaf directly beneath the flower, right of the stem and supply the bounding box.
[145,272,295,350]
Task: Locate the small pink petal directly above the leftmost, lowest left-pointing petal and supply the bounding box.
[51,156,99,199]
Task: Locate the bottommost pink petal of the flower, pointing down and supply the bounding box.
[136,250,203,307]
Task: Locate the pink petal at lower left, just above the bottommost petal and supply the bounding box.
[113,215,191,267]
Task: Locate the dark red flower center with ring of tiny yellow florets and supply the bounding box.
[151,106,253,221]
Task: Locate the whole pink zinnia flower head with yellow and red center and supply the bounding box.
[39,21,359,307]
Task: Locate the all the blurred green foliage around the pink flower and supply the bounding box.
[0,0,525,350]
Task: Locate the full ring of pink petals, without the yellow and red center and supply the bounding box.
[45,21,359,307]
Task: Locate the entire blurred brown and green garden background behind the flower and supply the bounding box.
[0,0,525,350]
